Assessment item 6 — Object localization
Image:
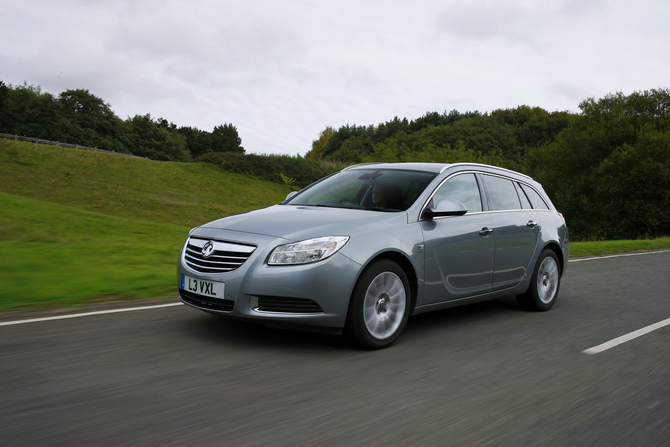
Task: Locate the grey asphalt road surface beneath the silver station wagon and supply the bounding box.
[0,252,670,446]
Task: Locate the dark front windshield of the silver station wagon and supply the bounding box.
[285,169,436,211]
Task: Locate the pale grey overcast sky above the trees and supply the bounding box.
[0,0,670,155]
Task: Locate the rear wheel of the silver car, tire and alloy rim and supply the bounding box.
[516,249,561,312]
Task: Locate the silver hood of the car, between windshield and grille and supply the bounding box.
[200,205,407,241]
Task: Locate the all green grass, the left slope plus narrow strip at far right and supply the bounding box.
[0,139,670,311]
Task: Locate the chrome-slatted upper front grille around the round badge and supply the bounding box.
[184,237,256,273]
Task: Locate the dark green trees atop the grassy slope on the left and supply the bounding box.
[0,81,244,161]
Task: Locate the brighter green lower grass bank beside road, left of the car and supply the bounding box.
[0,193,189,311]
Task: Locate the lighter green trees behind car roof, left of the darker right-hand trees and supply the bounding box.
[305,106,575,169]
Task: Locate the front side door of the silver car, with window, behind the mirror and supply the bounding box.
[421,173,495,304]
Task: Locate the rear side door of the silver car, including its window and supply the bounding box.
[481,174,540,290]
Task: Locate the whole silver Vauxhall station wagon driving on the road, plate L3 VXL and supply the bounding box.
[178,163,569,349]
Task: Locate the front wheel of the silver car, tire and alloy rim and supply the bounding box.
[345,259,412,349]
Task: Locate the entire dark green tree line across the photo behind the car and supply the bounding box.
[0,81,670,240]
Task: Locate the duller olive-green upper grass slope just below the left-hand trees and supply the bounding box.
[0,139,292,227]
